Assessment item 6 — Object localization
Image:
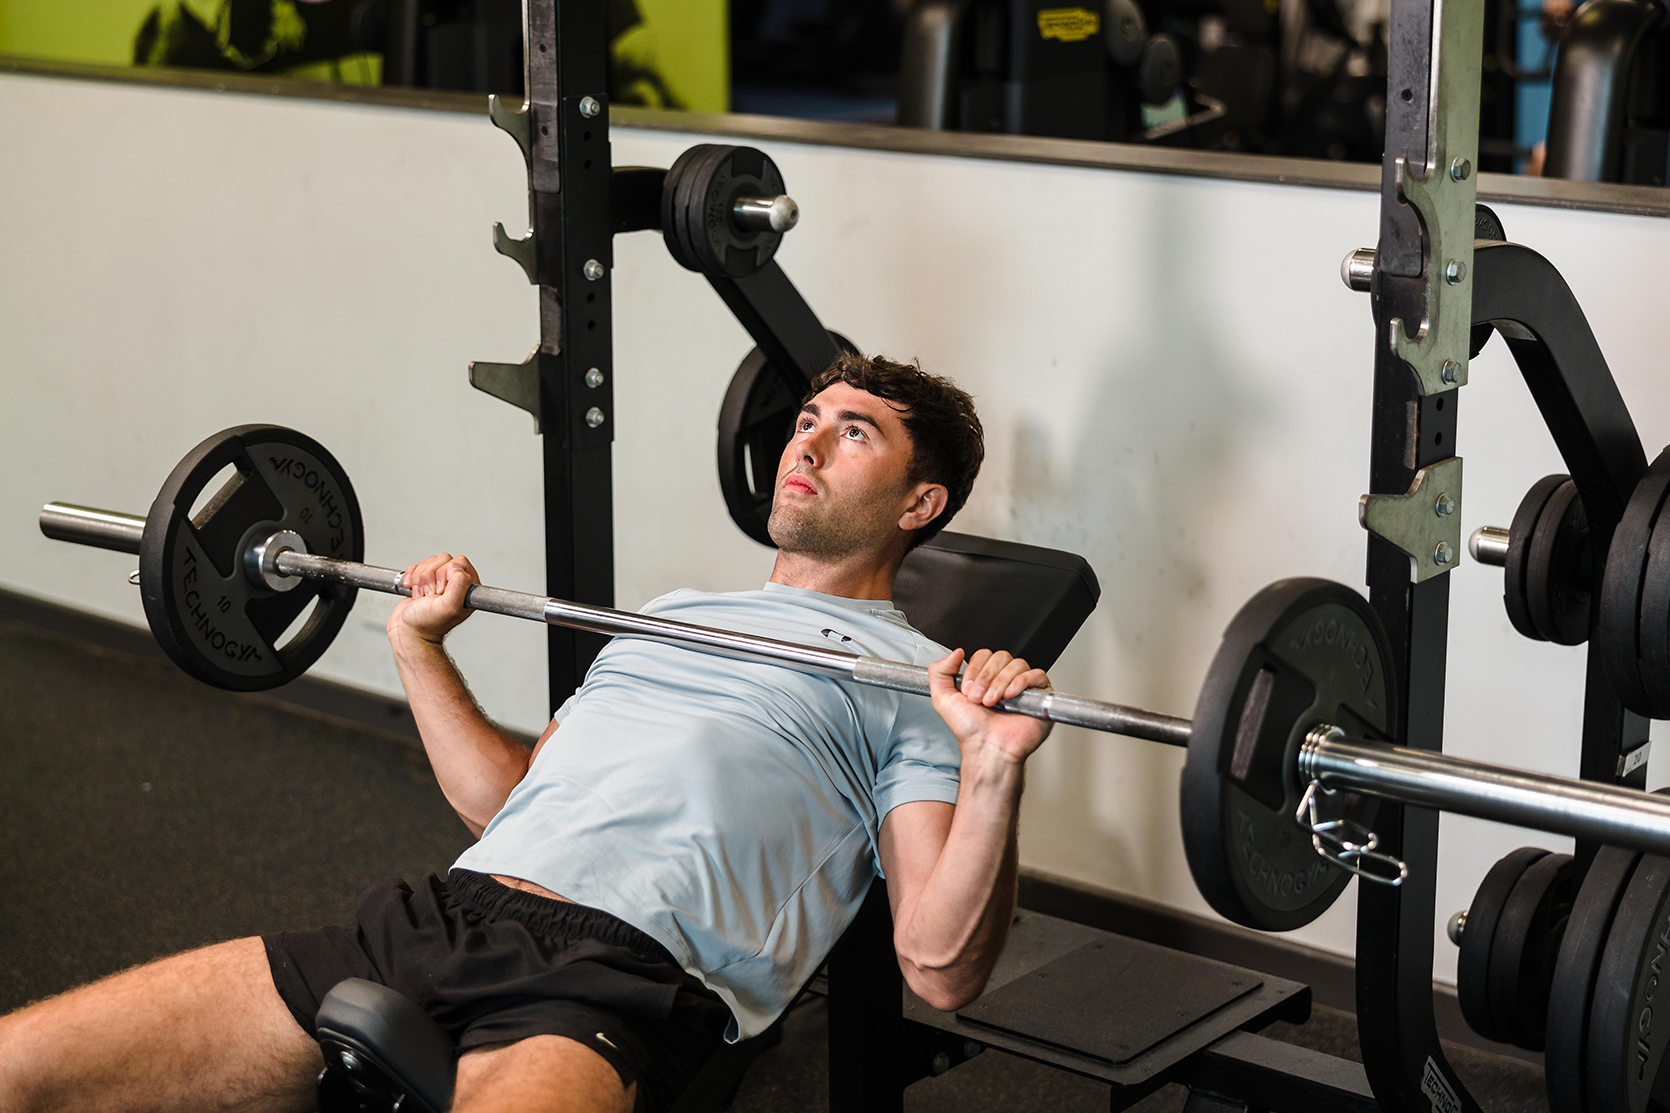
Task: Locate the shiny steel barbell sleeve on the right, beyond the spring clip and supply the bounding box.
[1299,727,1670,856]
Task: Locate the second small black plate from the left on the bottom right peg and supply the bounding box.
[1489,854,1581,1051]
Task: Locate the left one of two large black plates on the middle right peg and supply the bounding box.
[1595,448,1670,719]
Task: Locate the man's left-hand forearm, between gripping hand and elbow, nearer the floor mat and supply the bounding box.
[391,635,529,836]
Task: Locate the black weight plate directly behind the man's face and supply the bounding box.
[718,333,858,545]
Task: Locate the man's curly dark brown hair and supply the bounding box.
[805,353,985,548]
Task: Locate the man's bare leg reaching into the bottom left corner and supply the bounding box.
[0,939,324,1113]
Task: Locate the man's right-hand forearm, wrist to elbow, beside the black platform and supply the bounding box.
[893,760,1022,1008]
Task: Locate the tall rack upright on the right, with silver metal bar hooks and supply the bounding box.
[1356,0,1483,1113]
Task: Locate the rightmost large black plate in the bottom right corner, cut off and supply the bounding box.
[1583,854,1670,1113]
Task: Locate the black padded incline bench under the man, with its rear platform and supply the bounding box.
[319,533,1376,1113]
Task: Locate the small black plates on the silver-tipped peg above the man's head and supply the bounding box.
[661,144,798,279]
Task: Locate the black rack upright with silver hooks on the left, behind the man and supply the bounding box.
[471,0,615,709]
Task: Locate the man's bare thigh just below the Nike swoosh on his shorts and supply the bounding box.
[453,1036,638,1113]
